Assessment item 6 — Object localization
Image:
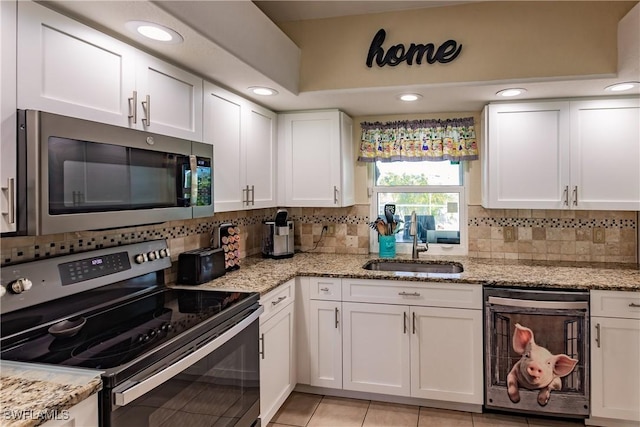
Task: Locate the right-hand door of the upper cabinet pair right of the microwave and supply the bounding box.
[242,102,277,209]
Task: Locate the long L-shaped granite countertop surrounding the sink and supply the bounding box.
[175,253,640,294]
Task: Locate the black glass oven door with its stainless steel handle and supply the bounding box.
[106,307,263,427]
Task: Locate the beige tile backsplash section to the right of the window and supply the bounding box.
[468,206,638,263]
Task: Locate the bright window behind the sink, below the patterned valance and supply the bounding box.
[370,161,467,255]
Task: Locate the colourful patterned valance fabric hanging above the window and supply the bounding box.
[358,117,478,162]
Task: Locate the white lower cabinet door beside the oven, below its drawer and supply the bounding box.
[260,303,296,426]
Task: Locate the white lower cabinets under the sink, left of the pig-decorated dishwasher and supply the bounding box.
[309,278,483,405]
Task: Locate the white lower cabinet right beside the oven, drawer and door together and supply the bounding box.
[260,280,296,426]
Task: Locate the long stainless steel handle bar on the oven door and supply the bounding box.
[114,306,264,406]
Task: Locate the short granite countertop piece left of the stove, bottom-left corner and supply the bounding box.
[0,360,102,427]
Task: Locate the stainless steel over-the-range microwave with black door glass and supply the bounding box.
[16,110,213,235]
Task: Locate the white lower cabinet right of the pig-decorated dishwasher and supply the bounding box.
[587,291,640,426]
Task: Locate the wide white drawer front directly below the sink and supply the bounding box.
[342,279,482,310]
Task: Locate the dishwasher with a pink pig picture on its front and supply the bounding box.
[484,287,589,418]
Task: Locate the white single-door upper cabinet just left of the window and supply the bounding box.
[278,110,355,207]
